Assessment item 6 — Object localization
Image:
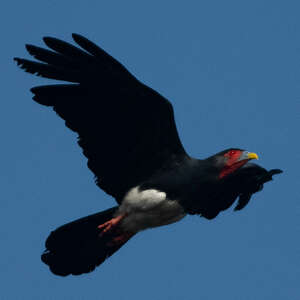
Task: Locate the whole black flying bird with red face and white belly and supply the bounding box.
[14,34,282,276]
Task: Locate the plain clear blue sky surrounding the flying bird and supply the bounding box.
[0,0,300,300]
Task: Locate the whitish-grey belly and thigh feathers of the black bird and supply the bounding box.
[117,187,186,232]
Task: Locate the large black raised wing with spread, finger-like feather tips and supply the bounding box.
[15,34,186,202]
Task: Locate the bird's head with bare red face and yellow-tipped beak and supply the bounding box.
[213,148,258,178]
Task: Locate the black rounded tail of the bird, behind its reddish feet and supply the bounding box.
[41,207,132,276]
